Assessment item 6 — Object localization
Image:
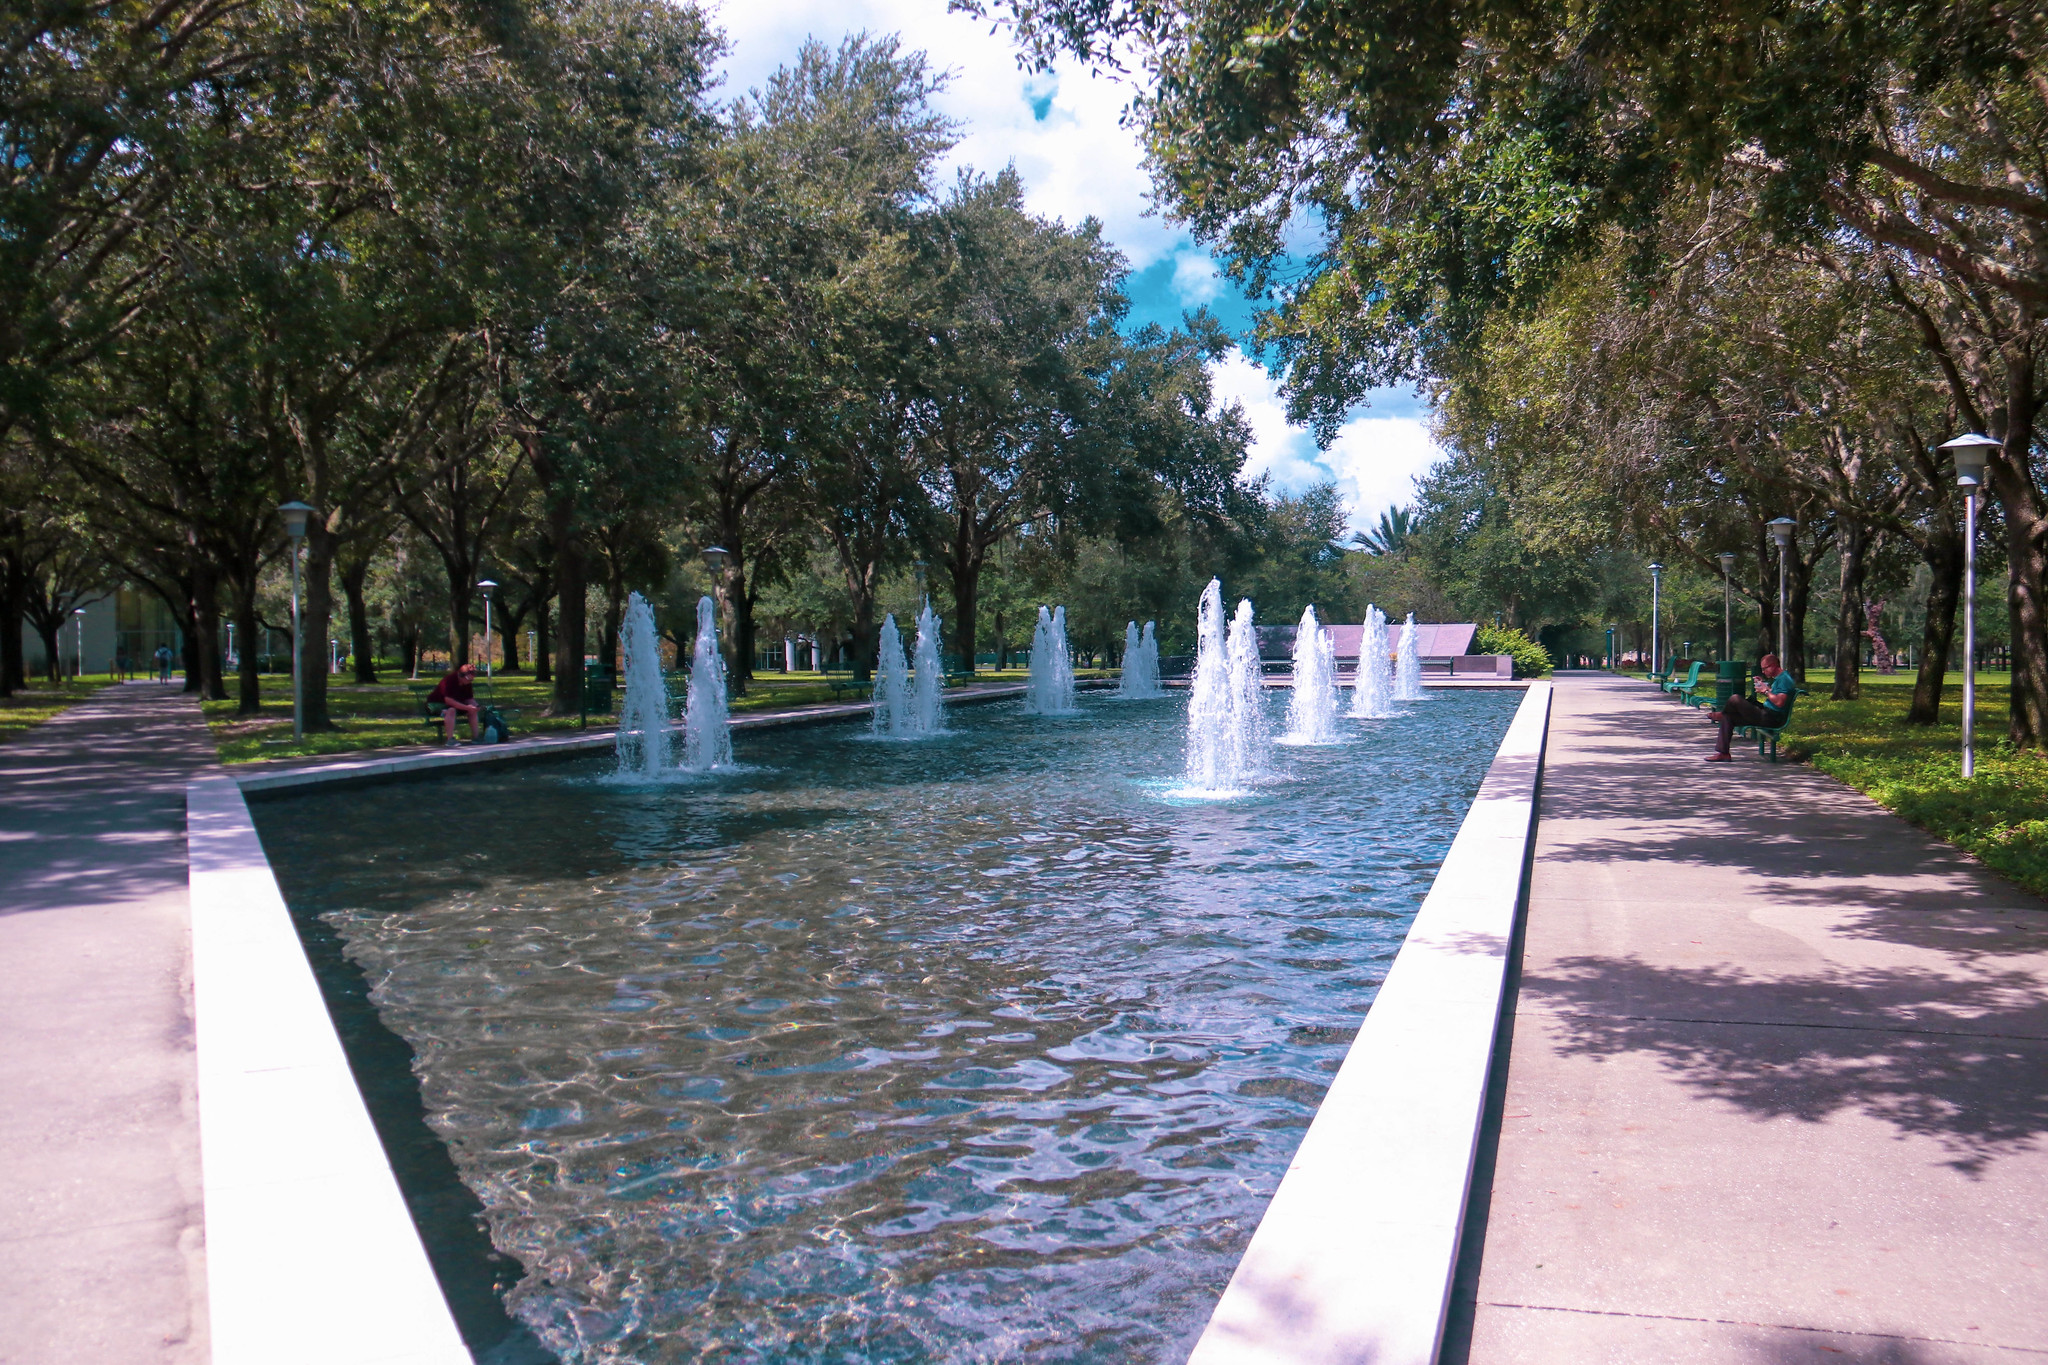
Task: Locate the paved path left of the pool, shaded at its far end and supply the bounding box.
[0,684,213,1365]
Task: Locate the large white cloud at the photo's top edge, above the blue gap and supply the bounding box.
[713,0,1186,270]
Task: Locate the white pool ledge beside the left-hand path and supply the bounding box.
[186,772,473,1365]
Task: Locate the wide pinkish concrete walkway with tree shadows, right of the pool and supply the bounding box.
[1446,675,2048,1365]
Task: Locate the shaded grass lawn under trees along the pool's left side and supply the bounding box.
[205,669,1073,763]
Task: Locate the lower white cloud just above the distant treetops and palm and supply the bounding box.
[1210,350,1444,530]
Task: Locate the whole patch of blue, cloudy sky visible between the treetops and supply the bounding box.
[713,0,1438,526]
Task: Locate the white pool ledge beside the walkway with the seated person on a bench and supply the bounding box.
[1188,681,1550,1365]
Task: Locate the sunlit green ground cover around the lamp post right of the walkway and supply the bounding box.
[1622,669,2048,896]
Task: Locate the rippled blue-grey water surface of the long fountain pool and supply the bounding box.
[256,692,1520,1363]
